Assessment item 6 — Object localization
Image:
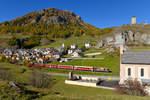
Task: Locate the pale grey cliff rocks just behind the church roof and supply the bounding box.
[96,26,150,48]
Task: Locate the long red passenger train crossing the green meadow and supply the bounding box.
[30,63,111,72]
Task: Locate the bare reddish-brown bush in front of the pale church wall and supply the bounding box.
[116,79,148,96]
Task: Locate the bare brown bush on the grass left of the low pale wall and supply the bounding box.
[29,71,52,88]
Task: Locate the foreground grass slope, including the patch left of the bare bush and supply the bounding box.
[0,63,150,100]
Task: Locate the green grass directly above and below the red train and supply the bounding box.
[46,58,119,76]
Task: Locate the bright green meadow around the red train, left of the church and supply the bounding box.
[44,51,120,76]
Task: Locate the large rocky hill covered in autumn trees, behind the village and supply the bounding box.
[0,8,104,38]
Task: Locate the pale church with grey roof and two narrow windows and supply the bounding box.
[120,45,150,84]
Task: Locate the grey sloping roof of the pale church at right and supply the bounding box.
[122,50,150,64]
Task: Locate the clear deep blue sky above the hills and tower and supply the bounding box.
[0,0,150,28]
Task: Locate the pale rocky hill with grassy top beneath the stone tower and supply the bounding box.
[97,24,150,48]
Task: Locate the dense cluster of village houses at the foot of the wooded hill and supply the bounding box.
[1,48,64,63]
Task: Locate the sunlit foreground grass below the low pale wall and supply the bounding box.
[38,77,150,100]
